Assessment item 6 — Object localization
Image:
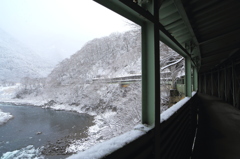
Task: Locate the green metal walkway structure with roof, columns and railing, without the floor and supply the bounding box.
[94,0,240,159]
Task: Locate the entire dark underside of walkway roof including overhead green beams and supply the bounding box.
[95,0,240,72]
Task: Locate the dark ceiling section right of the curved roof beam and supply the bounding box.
[181,0,240,72]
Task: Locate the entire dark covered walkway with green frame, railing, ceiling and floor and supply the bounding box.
[70,0,240,159]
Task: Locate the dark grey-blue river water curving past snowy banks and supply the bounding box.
[0,105,93,158]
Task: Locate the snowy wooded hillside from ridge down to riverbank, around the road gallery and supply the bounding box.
[13,30,184,151]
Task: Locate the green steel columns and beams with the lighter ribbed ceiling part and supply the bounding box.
[95,0,200,124]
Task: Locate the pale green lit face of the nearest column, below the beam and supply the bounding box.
[142,23,155,125]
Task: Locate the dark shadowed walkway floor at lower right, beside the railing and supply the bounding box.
[192,94,240,159]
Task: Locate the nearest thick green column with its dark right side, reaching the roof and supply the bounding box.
[142,0,160,127]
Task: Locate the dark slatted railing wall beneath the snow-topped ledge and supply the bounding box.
[100,94,197,159]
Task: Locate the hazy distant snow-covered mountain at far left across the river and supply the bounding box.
[0,29,53,82]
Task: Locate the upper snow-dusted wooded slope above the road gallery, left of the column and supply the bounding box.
[48,31,141,85]
